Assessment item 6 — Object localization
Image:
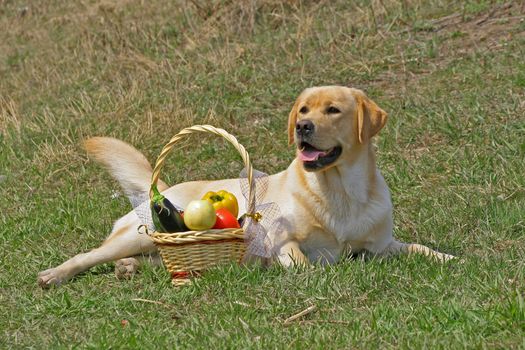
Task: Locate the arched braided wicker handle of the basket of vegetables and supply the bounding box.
[149,125,255,214]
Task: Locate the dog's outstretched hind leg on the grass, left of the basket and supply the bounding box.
[37,216,157,288]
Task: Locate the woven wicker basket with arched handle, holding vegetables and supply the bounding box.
[149,125,255,286]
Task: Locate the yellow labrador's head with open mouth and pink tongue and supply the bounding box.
[288,86,387,171]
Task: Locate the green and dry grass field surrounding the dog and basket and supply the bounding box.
[0,0,525,349]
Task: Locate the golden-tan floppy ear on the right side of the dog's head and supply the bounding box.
[354,91,388,143]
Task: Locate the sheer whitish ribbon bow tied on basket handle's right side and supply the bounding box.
[239,169,281,258]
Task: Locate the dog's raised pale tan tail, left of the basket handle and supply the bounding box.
[84,137,168,197]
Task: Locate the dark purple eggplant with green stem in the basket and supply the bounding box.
[150,186,188,233]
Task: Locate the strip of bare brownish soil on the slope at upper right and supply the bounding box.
[372,2,525,95]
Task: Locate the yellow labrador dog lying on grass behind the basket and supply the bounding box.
[38,86,453,287]
